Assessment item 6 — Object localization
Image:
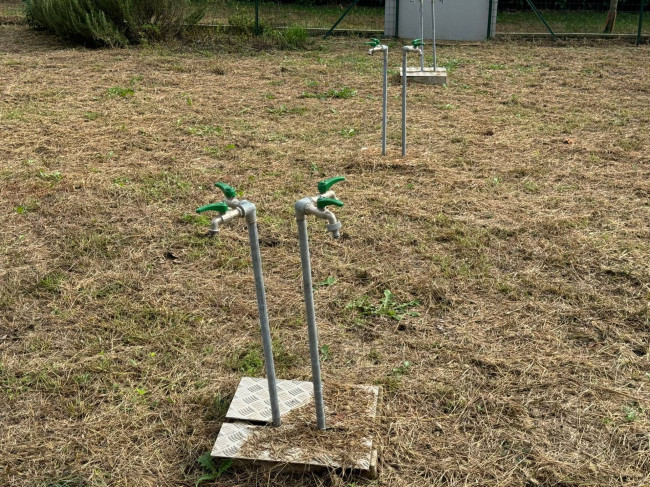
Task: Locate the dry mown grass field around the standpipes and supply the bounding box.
[0,11,650,487]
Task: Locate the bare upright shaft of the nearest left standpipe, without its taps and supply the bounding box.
[248,221,281,426]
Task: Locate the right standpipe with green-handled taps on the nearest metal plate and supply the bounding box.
[295,176,345,430]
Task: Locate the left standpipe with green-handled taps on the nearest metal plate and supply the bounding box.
[196,183,281,426]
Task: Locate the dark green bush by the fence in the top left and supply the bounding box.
[25,0,204,46]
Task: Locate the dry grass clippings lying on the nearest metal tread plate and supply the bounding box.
[240,384,378,468]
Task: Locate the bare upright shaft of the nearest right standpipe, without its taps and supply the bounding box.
[296,215,325,430]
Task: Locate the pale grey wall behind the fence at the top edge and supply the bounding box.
[384,0,497,41]
